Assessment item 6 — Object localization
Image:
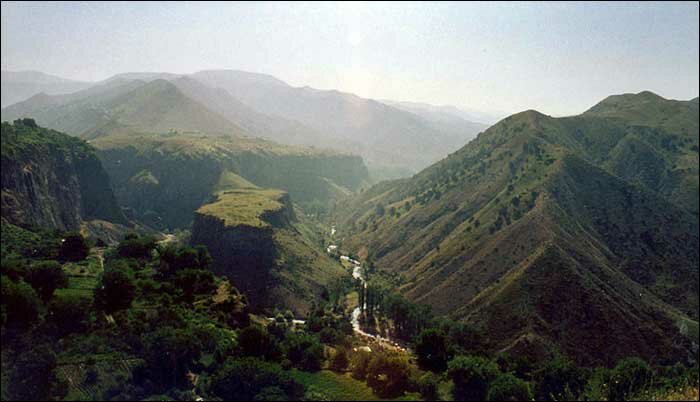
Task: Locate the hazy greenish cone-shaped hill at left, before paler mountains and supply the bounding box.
[2,79,243,138]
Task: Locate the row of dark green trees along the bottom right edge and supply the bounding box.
[414,324,698,401]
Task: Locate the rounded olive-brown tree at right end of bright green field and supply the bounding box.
[367,352,410,398]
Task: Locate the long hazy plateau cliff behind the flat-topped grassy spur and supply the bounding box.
[94,134,367,228]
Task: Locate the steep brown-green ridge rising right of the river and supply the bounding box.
[338,94,698,364]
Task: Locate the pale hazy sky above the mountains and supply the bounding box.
[2,1,700,115]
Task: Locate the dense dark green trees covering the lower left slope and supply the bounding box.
[2,222,344,400]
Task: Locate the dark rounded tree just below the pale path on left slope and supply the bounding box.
[95,261,136,313]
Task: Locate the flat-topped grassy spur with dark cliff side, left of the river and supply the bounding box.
[190,188,344,316]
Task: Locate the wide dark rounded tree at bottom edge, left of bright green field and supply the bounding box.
[210,357,304,401]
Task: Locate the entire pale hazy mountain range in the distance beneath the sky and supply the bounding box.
[2,70,487,180]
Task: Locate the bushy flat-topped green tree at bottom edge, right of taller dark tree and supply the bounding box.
[447,356,500,401]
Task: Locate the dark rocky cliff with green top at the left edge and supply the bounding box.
[2,119,126,230]
